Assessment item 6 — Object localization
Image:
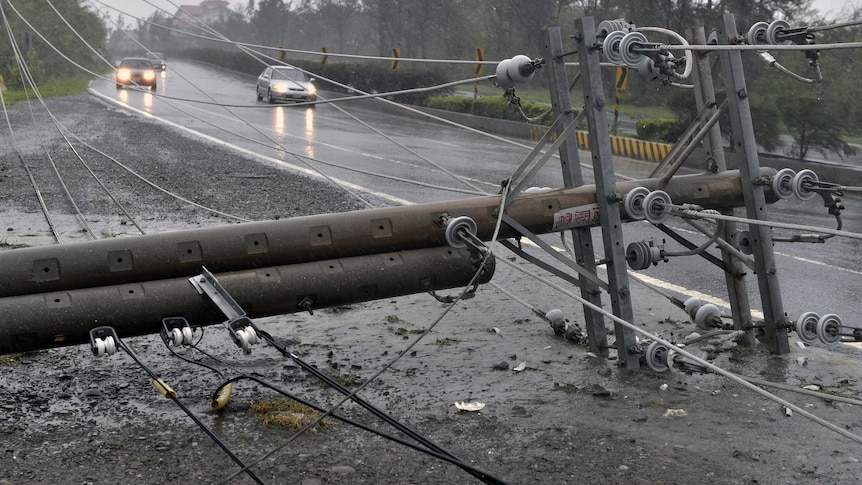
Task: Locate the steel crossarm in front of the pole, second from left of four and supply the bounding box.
[574,17,641,368]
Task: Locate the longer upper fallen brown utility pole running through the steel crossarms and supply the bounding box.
[0,168,778,297]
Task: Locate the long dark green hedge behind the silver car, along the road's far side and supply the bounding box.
[178,48,451,104]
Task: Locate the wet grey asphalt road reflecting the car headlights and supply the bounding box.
[93,61,862,344]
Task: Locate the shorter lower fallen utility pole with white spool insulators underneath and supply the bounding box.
[0,247,494,354]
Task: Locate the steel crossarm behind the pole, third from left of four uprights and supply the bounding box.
[691,27,754,346]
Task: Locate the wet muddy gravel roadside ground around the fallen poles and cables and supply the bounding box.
[0,95,862,485]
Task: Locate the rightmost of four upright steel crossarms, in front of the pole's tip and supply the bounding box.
[718,14,790,354]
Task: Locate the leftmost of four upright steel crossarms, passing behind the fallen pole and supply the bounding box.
[545,27,609,357]
